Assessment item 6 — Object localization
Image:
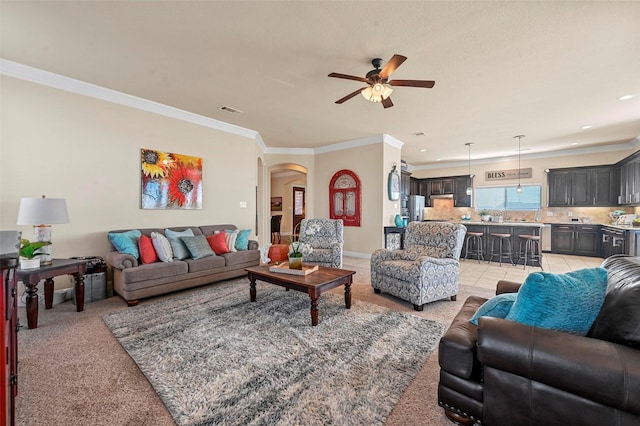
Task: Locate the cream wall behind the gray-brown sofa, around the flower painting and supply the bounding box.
[0,77,260,258]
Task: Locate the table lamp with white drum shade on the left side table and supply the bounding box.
[17,195,69,265]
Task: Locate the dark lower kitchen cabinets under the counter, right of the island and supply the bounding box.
[551,224,601,257]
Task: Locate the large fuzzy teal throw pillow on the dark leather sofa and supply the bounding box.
[505,268,607,336]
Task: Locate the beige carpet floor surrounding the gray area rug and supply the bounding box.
[17,258,497,426]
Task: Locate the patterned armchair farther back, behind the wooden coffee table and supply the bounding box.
[299,219,343,268]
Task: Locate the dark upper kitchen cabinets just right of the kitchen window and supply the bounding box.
[547,166,618,207]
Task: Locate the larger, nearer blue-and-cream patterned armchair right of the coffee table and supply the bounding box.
[371,222,467,311]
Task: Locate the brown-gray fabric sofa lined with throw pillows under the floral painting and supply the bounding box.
[106,225,260,306]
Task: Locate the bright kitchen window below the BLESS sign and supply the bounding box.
[476,185,542,210]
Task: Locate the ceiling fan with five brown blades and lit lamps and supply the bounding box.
[329,54,436,108]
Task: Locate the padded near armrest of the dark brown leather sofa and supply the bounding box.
[478,317,640,413]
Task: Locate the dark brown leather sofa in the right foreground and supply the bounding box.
[438,255,640,426]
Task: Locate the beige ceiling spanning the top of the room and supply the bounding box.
[0,1,640,166]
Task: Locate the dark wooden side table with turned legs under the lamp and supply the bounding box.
[17,259,87,328]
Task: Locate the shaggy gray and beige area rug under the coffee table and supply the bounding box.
[103,280,445,425]
